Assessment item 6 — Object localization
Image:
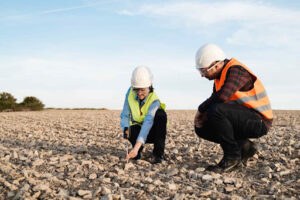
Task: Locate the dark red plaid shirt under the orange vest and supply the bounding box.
[198,59,273,128]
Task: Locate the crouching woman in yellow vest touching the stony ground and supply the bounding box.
[121,67,167,164]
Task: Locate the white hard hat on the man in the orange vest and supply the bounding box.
[196,44,226,69]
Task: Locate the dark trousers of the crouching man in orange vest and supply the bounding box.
[195,103,268,159]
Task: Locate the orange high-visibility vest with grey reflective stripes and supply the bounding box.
[215,58,273,119]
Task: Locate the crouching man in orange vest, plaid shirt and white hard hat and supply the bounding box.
[194,44,273,172]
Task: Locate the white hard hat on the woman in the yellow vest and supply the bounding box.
[131,66,152,88]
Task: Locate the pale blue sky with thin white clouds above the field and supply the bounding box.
[0,0,300,109]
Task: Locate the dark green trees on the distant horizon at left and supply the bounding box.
[0,92,45,111]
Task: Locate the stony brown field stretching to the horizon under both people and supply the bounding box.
[0,110,300,200]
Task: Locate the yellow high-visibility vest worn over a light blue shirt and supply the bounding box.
[128,88,166,125]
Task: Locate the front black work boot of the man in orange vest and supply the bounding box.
[205,157,242,173]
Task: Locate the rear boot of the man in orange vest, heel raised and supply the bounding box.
[238,139,257,166]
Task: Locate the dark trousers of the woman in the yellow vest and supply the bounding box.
[129,109,167,157]
